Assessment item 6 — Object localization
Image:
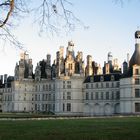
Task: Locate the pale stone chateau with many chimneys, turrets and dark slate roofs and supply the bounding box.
[0,31,140,116]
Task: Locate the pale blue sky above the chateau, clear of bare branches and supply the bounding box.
[0,0,140,75]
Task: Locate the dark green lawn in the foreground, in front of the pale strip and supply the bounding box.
[0,117,140,140]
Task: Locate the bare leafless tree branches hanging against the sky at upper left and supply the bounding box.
[0,0,84,48]
